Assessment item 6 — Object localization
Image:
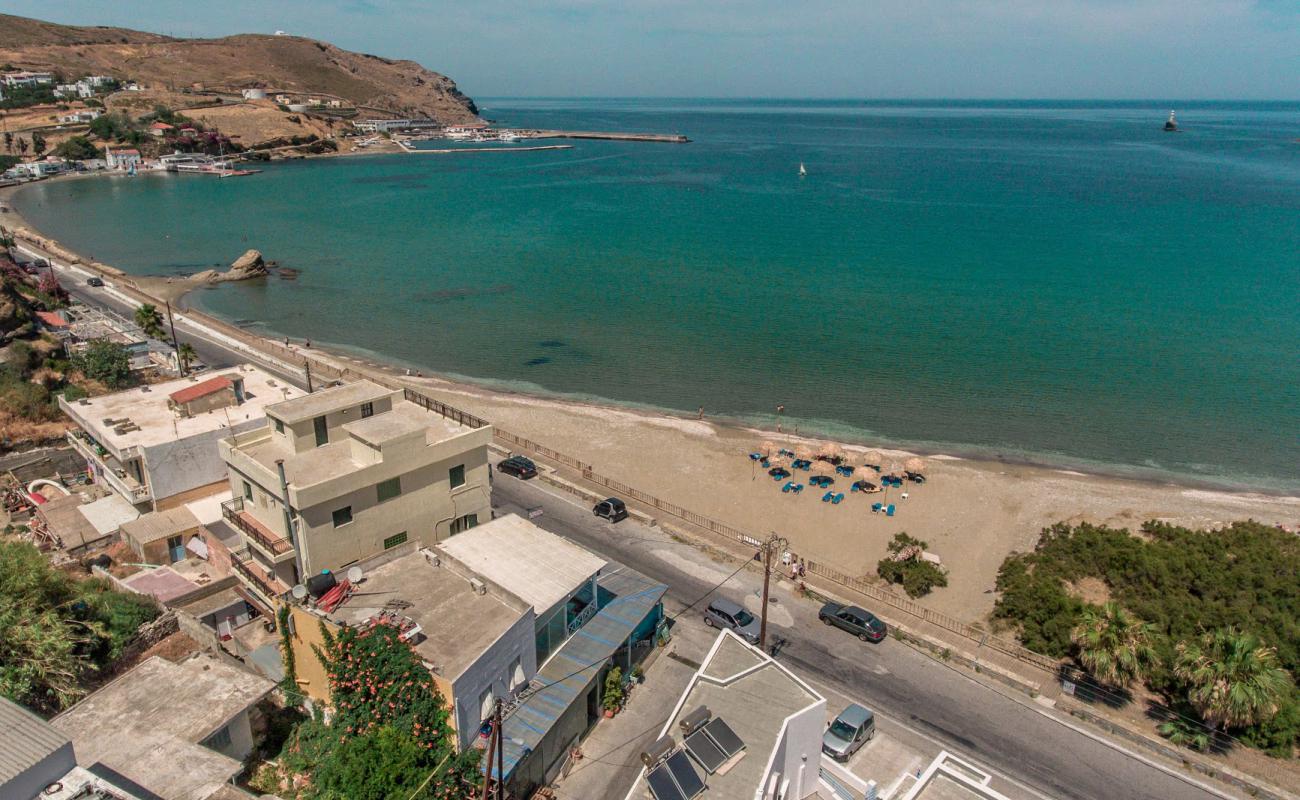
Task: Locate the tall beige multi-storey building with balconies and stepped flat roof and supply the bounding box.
[220,381,491,604]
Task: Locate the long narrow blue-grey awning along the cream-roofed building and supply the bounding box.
[491,572,668,778]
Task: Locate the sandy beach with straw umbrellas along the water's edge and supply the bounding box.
[0,175,1300,622]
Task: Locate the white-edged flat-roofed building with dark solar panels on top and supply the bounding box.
[627,631,827,800]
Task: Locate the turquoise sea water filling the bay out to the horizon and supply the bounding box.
[16,100,1300,492]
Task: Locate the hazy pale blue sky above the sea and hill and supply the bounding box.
[0,0,1300,100]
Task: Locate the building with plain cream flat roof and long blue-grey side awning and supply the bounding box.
[433,515,668,797]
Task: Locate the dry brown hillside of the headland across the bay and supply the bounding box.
[0,14,478,122]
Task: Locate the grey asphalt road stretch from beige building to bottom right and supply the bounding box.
[493,471,1238,800]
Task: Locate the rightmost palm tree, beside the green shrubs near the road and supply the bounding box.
[1174,627,1291,731]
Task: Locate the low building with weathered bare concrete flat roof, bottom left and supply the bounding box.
[51,653,276,800]
